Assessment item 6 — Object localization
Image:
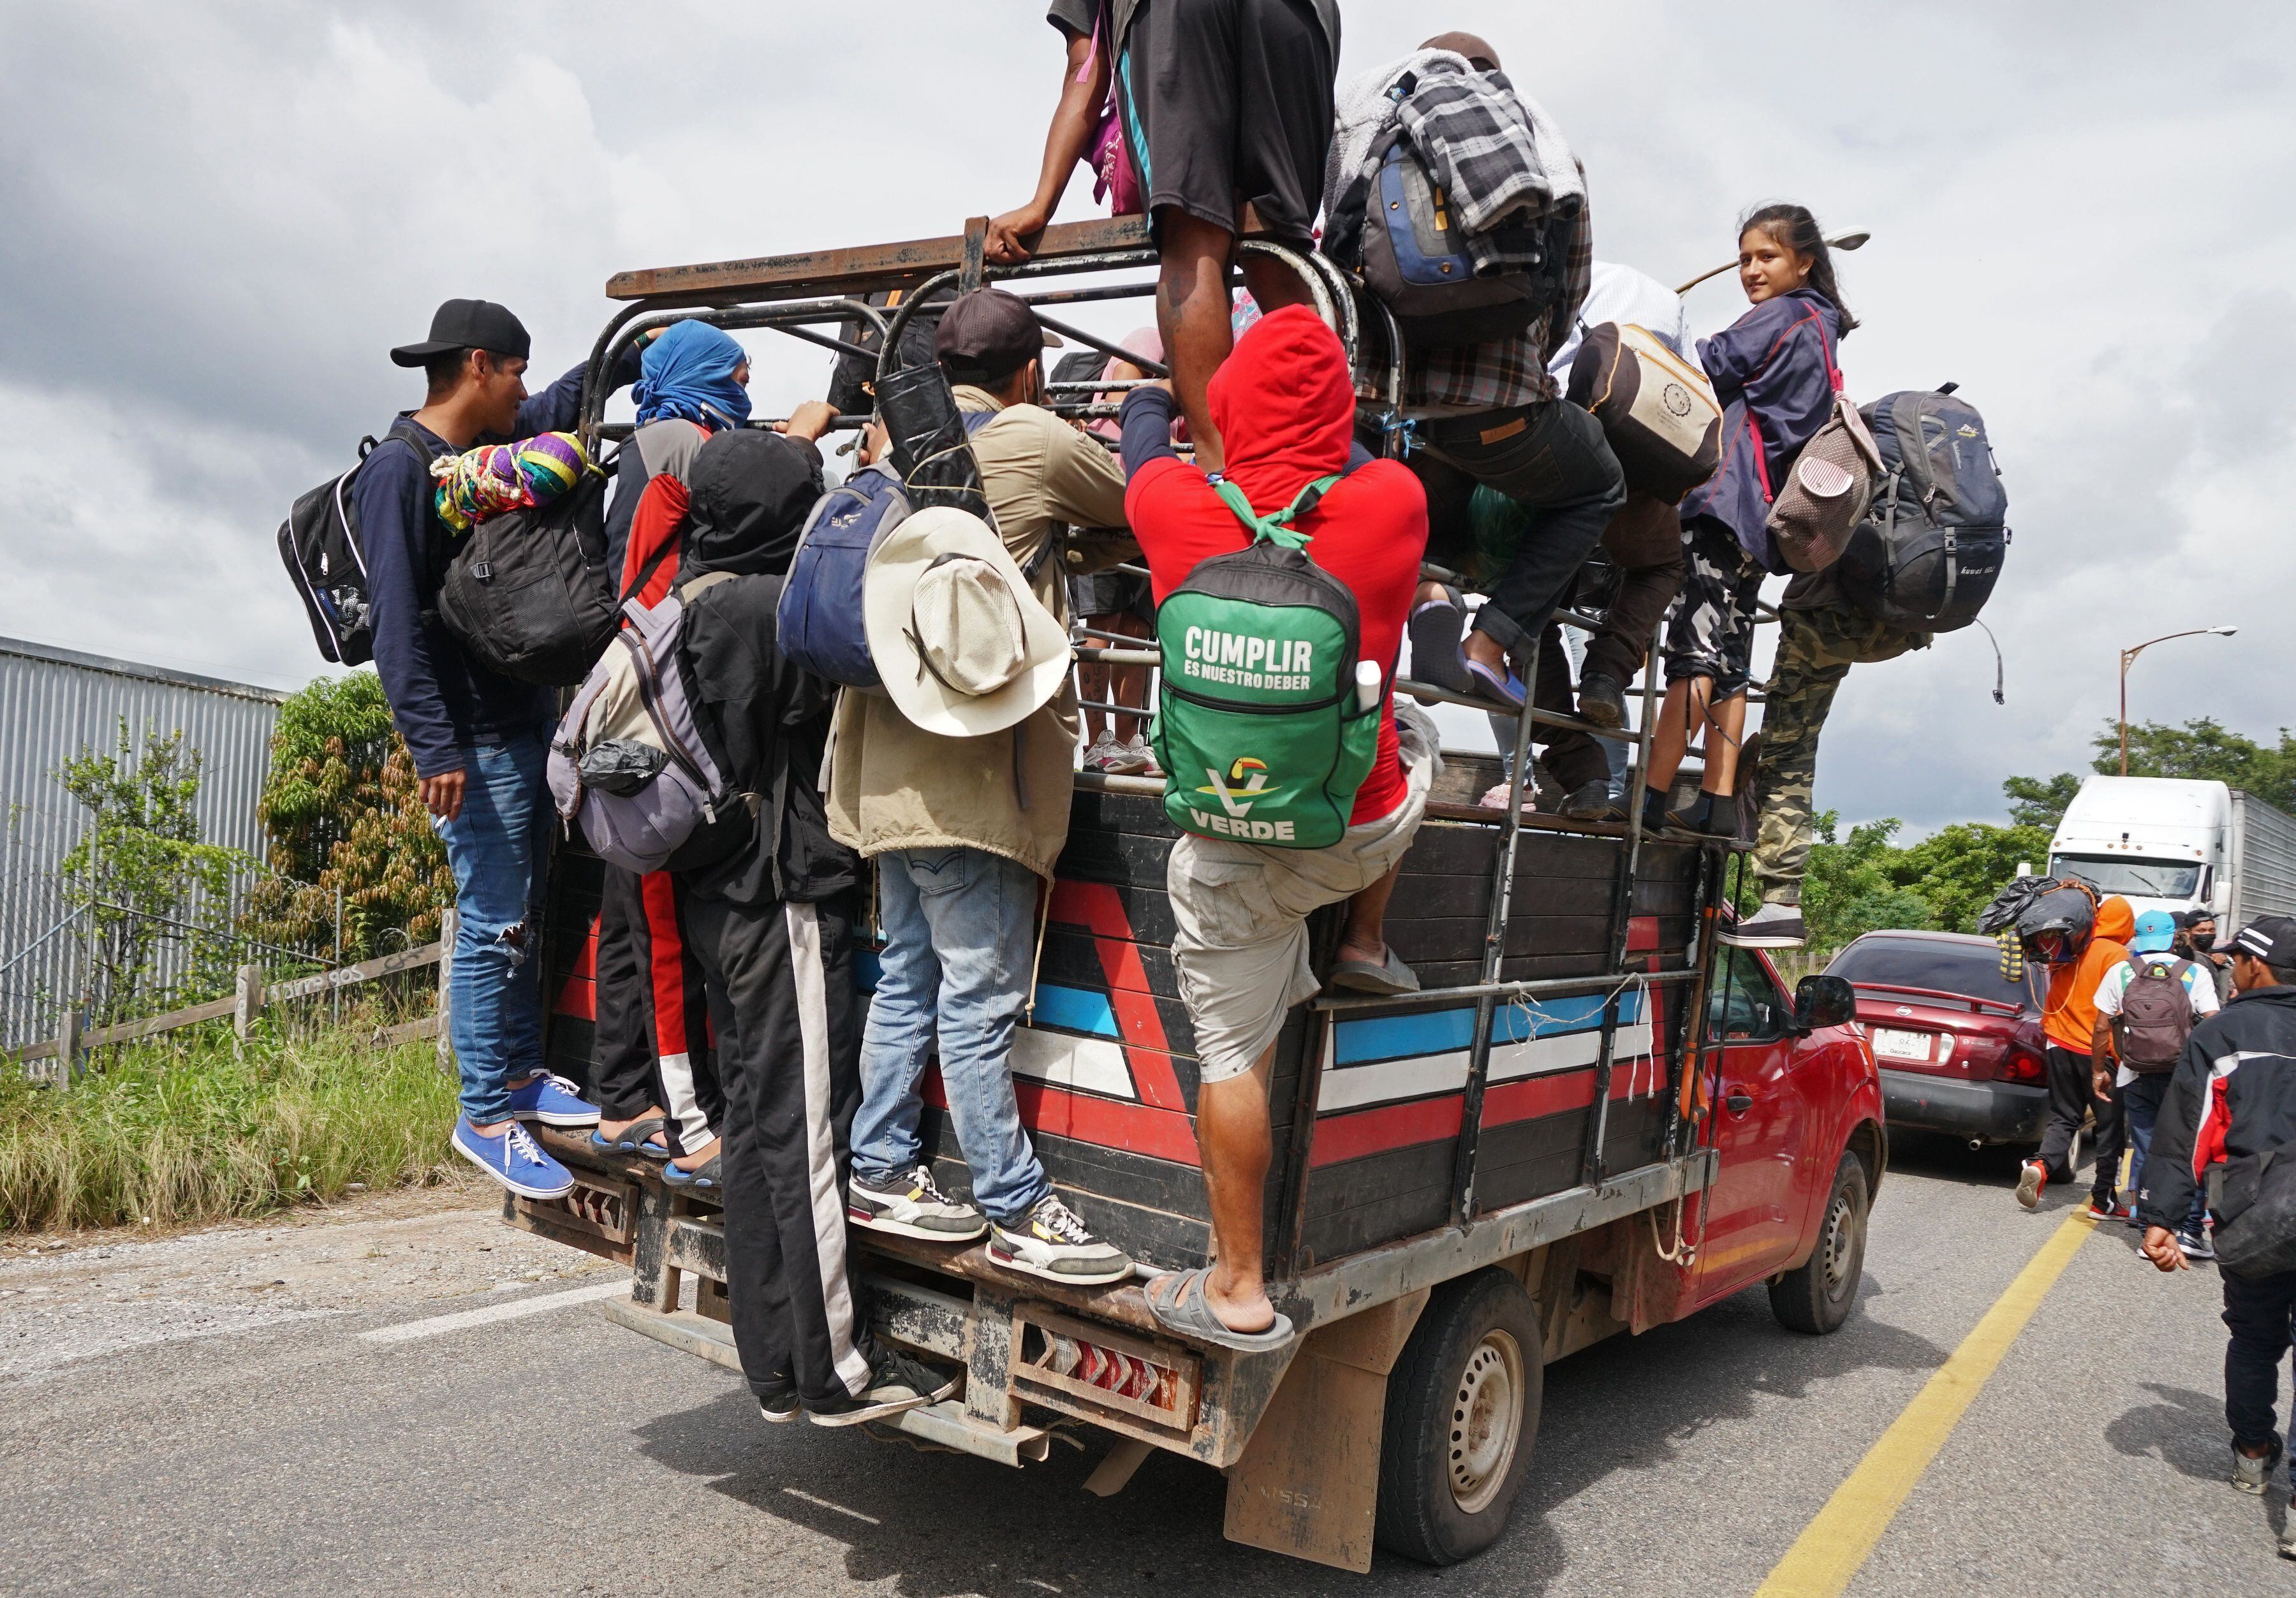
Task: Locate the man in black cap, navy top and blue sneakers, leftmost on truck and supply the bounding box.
[351,298,636,1199]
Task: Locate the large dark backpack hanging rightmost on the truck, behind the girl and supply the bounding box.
[1834,383,2009,634]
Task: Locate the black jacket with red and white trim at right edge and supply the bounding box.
[2138,987,2296,1231]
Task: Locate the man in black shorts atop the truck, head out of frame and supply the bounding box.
[987,0,1339,471]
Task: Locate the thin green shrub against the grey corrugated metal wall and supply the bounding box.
[55,716,253,1022]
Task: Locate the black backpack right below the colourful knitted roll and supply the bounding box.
[439,471,624,689]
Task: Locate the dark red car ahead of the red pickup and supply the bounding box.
[1825,932,2048,1146]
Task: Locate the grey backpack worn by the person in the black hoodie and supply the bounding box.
[548,572,751,875]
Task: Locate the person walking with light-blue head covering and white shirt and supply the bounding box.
[2089,909,2220,1261]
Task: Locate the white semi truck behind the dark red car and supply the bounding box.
[2048,776,2296,934]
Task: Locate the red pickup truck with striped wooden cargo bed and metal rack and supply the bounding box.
[505,218,1885,1571]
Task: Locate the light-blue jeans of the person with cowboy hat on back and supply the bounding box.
[854,849,1052,1226]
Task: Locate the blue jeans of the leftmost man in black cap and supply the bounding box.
[432,733,554,1125]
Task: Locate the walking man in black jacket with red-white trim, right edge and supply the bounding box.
[2138,916,2296,1559]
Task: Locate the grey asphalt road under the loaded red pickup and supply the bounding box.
[0,1141,2296,1598]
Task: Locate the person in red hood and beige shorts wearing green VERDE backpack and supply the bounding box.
[1122,305,1438,1350]
